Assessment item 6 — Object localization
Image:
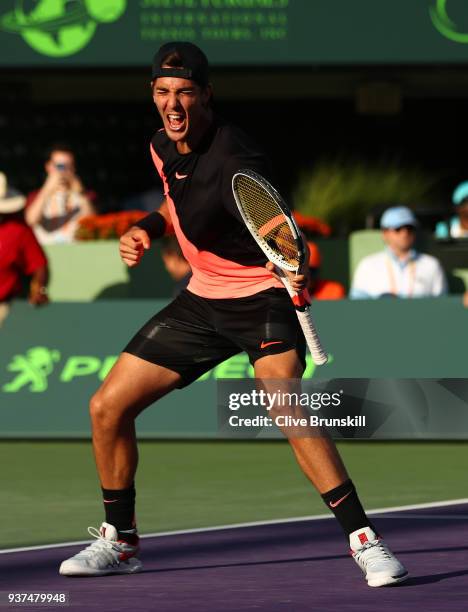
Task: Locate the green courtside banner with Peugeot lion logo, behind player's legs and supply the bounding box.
[0,297,468,438]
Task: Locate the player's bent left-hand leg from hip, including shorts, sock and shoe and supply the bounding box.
[60,291,239,576]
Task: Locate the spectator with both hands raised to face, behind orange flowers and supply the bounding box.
[25,144,95,244]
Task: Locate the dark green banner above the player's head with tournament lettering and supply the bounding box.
[0,0,468,66]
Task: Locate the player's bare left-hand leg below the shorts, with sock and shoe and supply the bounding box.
[60,353,181,576]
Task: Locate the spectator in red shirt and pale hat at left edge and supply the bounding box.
[0,173,48,325]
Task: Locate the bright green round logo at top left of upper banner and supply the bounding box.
[0,0,127,57]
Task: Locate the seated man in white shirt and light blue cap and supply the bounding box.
[350,206,447,299]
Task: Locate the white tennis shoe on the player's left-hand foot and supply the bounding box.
[59,523,143,576]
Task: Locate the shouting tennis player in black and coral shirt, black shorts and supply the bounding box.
[60,42,407,586]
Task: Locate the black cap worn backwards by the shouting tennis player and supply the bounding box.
[151,41,209,87]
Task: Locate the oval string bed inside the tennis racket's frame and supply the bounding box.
[235,176,299,266]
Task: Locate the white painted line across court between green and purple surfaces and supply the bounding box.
[0,498,468,555]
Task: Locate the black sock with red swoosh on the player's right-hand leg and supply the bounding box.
[322,480,377,537]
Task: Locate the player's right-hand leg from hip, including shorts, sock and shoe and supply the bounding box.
[225,289,407,586]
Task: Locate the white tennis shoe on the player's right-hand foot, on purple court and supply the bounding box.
[349,527,408,587]
